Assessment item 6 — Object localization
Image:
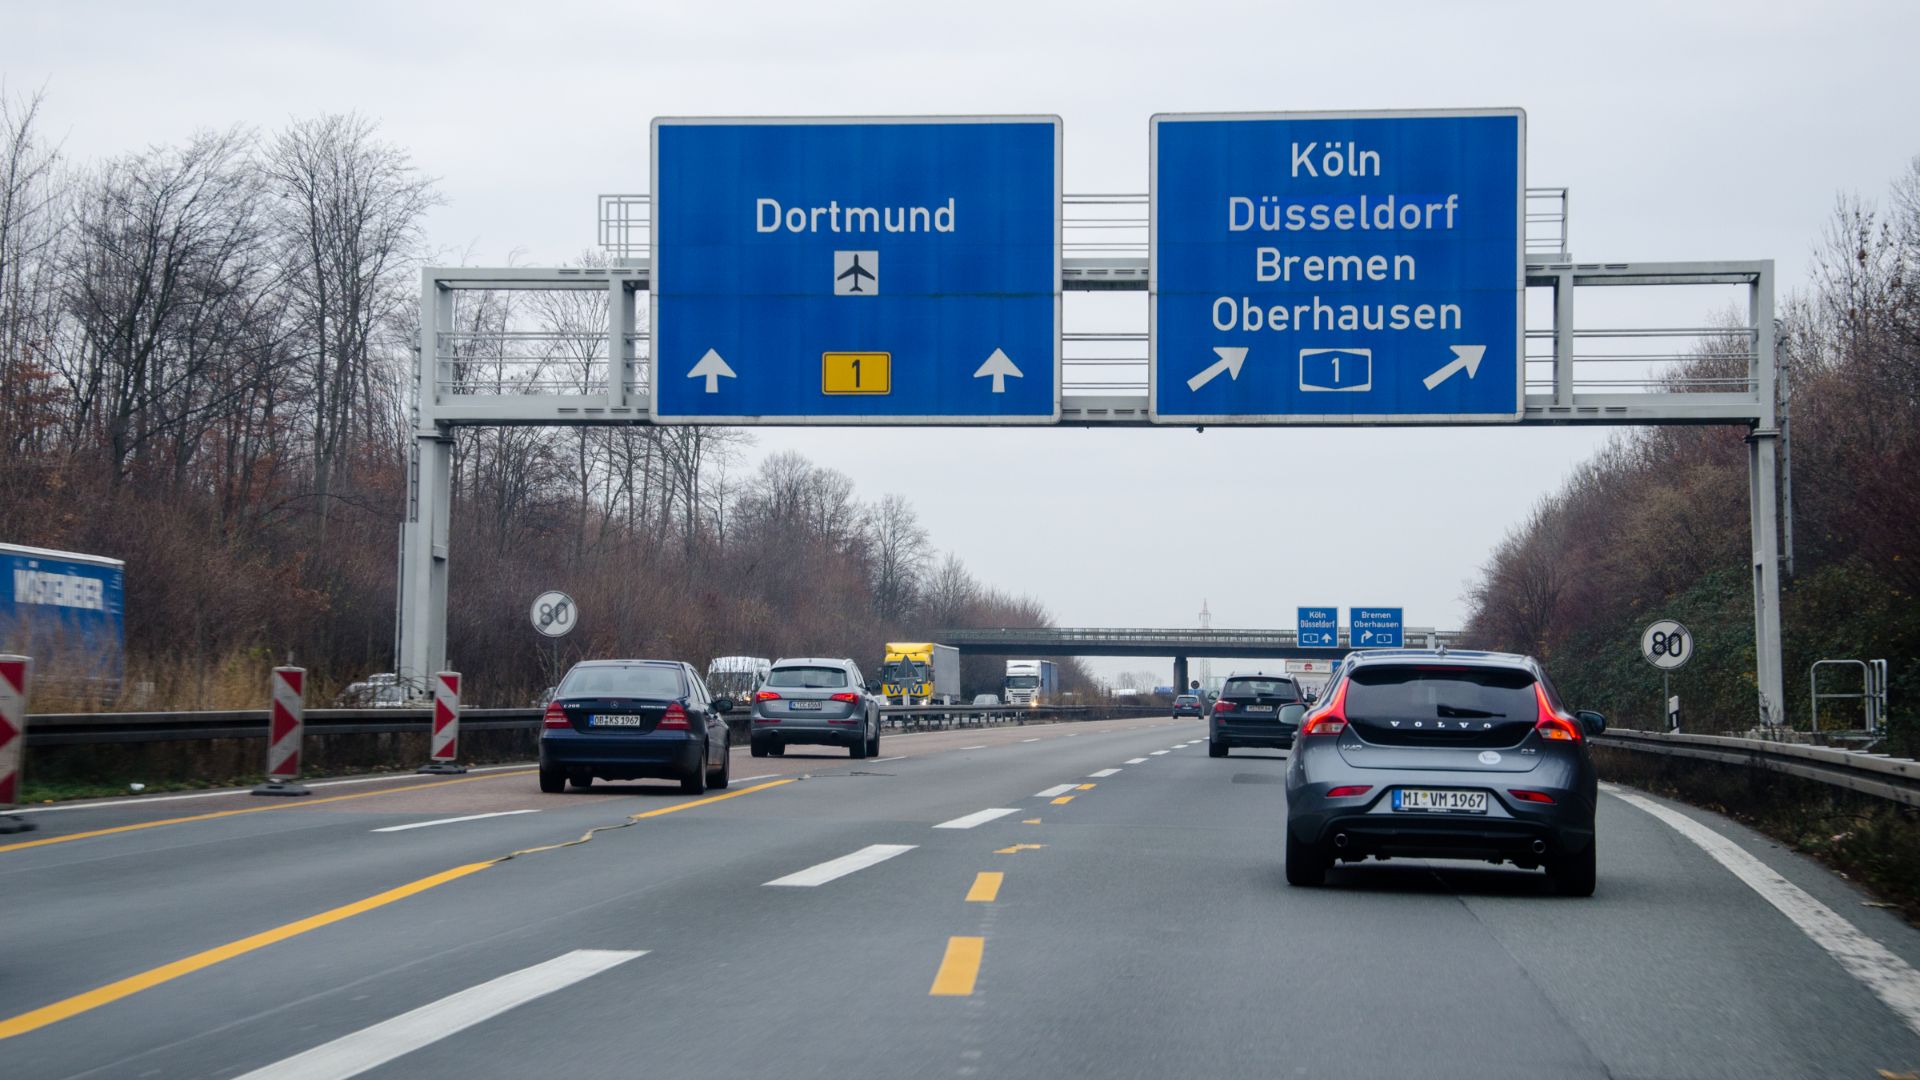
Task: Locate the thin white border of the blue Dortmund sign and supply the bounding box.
[647,113,1066,427]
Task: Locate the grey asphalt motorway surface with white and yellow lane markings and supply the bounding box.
[0,719,1920,1080]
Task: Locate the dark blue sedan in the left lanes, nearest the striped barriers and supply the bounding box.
[540,659,733,794]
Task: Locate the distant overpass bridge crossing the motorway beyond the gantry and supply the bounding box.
[935,626,1463,686]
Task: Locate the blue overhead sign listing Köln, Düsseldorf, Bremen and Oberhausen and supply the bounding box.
[1148,110,1526,425]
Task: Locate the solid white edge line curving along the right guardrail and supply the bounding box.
[1607,784,1920,1034]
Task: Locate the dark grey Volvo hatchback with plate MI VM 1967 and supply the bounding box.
[1286,650,1607,896]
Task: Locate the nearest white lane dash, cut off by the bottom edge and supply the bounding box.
[238,949,647,1080]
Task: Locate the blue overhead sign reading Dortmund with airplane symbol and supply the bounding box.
[651,117,1062,425]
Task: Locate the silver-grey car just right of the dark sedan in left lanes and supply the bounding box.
[749,657,879,757]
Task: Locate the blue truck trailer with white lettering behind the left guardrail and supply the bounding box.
[0,544,127,700]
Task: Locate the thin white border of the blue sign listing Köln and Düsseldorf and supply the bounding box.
[1136,108,1526,427]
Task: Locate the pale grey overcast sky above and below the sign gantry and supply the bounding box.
[0,0,1920,673]
